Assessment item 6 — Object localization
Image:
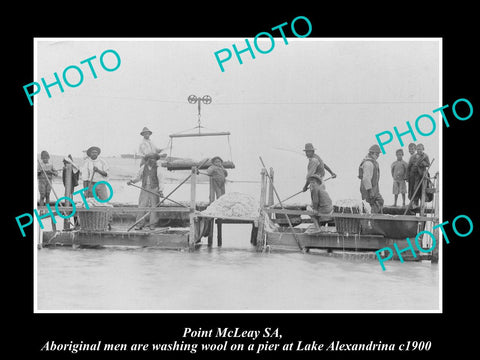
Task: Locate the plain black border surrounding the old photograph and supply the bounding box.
[2,2,480,359]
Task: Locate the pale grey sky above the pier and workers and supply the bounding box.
[36,38,443,203]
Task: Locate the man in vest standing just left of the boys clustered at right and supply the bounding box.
[358,144,384,213]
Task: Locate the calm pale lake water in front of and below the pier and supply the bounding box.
[37,224,439,311]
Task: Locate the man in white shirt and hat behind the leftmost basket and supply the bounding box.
[80,146,110,200]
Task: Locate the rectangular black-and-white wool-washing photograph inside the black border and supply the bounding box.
[32,36,442,312]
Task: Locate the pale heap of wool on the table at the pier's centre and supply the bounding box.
[202,192,259,218]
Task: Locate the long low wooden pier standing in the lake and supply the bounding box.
[38,166,438,259]
